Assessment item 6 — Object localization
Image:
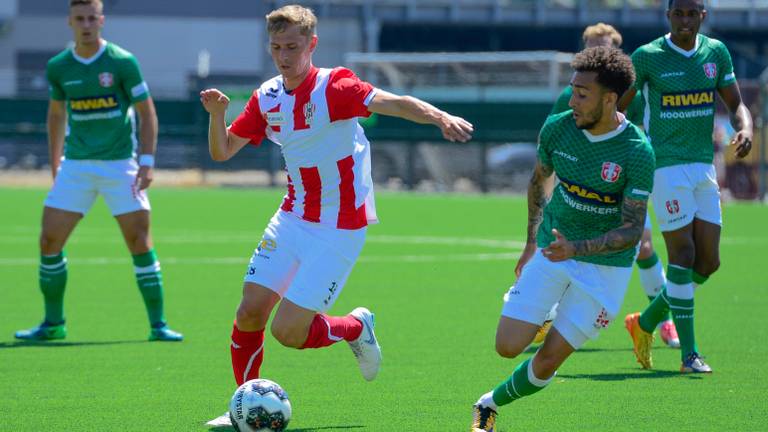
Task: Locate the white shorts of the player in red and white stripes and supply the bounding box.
[245,210,367,312]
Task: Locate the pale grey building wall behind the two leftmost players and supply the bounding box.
[9,14,362,98]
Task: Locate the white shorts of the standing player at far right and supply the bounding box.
[651,163,723,231]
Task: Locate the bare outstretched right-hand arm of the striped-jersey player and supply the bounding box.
[368,90,474,142]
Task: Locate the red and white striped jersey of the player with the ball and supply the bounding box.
[229,67,378,229]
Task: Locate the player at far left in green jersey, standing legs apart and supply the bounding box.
[16,0,182,341]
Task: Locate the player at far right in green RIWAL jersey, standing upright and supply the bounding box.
[620,0,753,373]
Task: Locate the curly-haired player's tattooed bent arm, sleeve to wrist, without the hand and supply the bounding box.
[572,198,648,256]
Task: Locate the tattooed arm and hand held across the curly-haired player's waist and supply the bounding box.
[544,197,648,261]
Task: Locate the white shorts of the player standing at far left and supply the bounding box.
[45,159,150,216]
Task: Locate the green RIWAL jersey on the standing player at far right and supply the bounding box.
[632,35,736,168]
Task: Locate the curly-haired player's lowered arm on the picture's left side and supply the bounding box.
[515,160,554,277]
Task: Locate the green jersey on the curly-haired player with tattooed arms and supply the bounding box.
[537,110,655,267]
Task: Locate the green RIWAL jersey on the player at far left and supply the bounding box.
[46,42,149,160]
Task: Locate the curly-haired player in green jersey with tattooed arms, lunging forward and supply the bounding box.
[470,46,654,432]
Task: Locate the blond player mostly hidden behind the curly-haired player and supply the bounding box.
[544,23,680,348]
